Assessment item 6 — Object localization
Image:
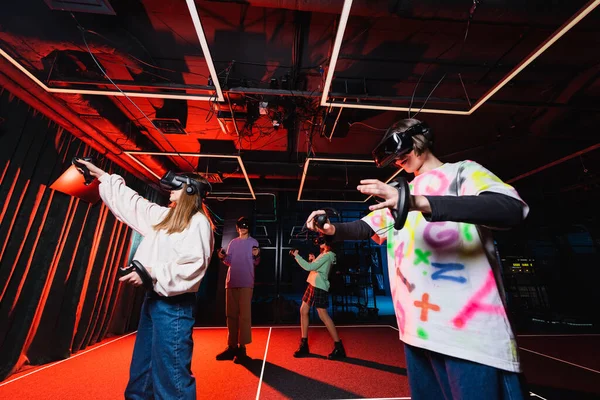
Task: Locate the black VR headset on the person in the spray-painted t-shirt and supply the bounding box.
[373,122,431,168]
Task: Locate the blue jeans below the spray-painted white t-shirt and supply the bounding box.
[404,344,528,400]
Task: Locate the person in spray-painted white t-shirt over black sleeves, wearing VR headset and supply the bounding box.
[307,119,529,399]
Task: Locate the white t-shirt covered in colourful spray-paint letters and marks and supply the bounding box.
[363,161,529,372]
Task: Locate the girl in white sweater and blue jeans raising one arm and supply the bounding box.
[78,160,214,399]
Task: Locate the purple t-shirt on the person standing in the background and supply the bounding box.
[223,236,259,288]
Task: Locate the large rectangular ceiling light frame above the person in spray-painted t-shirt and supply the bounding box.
[321,0,600,115]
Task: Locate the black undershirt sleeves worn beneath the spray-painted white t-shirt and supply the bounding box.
[331,192,523,242]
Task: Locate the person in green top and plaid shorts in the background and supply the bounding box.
[290,238,346,360]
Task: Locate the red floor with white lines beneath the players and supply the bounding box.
[0,326,600,400]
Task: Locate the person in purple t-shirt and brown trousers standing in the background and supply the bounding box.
[217,217,260,364]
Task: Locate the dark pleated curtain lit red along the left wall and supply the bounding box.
[0,91,145,380]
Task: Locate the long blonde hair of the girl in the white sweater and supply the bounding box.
[154,173,215,235]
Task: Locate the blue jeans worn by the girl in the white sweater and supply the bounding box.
[125,292,196,400]
